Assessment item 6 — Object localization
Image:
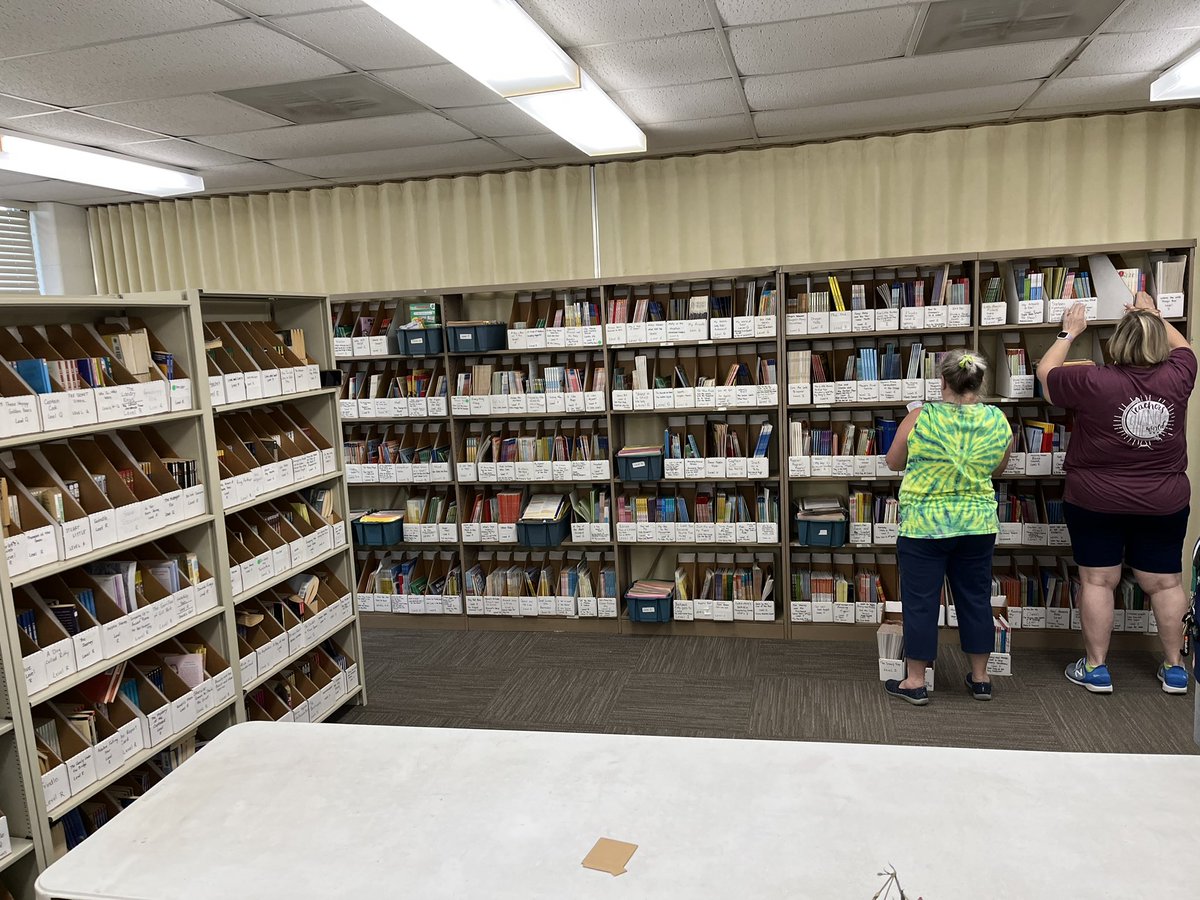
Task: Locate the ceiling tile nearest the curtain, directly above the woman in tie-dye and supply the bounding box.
[754,82,1038,137]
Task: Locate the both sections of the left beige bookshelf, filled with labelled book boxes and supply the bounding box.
[0,292,364,898]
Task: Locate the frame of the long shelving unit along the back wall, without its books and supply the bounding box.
[330,240,1195,644]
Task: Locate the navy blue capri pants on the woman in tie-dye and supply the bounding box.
[896,534,996,661]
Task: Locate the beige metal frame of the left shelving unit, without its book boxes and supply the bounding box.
[0,292,365,900]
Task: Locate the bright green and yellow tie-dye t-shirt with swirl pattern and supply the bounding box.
[900,403,1013,538]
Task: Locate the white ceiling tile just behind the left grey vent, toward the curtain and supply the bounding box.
[196,113,473,160]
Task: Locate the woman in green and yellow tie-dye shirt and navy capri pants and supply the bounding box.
[884,350,1013,706]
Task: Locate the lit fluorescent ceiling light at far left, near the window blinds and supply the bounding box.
[0,132,204,197]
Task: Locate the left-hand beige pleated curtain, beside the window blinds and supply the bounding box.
[89,167,595,293]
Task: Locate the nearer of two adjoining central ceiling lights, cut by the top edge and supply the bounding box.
[364,0,580,97]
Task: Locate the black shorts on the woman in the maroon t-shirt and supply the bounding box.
[1063,503,1192,575]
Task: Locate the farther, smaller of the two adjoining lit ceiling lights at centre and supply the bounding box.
[509,72,646,156]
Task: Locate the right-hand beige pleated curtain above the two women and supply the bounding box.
[596,109,1200,276]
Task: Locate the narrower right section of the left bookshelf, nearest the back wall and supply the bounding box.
[197,292,366,722]
